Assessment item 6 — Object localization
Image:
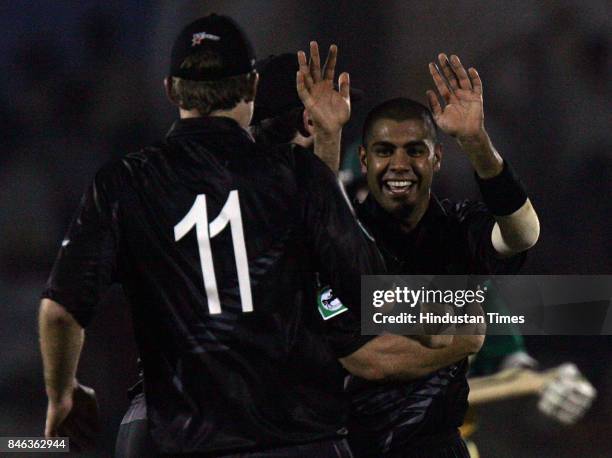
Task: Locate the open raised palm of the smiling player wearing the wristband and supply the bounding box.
[427,54,484,138]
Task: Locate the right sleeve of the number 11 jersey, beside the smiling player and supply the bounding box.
[296,150,385,357]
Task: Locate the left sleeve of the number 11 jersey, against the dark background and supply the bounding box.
[42,166,118,327]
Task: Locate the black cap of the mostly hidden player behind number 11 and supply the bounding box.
[252,53,363,123]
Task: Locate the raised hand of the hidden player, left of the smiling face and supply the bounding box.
[296,41,351,134]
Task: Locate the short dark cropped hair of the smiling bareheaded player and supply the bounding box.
[361,97,438,146]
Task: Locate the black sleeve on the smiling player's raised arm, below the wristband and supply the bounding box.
[453,201,527,275]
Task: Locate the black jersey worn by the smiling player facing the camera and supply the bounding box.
[347,195,525,457]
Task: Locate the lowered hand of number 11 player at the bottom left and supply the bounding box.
[45,384,100,451]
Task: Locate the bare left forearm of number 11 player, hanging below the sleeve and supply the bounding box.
[38,299,85,402]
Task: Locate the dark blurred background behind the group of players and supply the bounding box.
[0,0,612,458]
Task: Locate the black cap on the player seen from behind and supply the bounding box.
[170,14,255,81]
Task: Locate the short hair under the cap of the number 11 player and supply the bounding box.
[170,52,255,116]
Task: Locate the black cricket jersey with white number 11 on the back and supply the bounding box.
[43,117,382,453]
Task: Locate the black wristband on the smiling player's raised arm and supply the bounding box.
[476,160,527,216]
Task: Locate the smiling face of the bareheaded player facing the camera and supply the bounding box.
[359,118,442,219]
